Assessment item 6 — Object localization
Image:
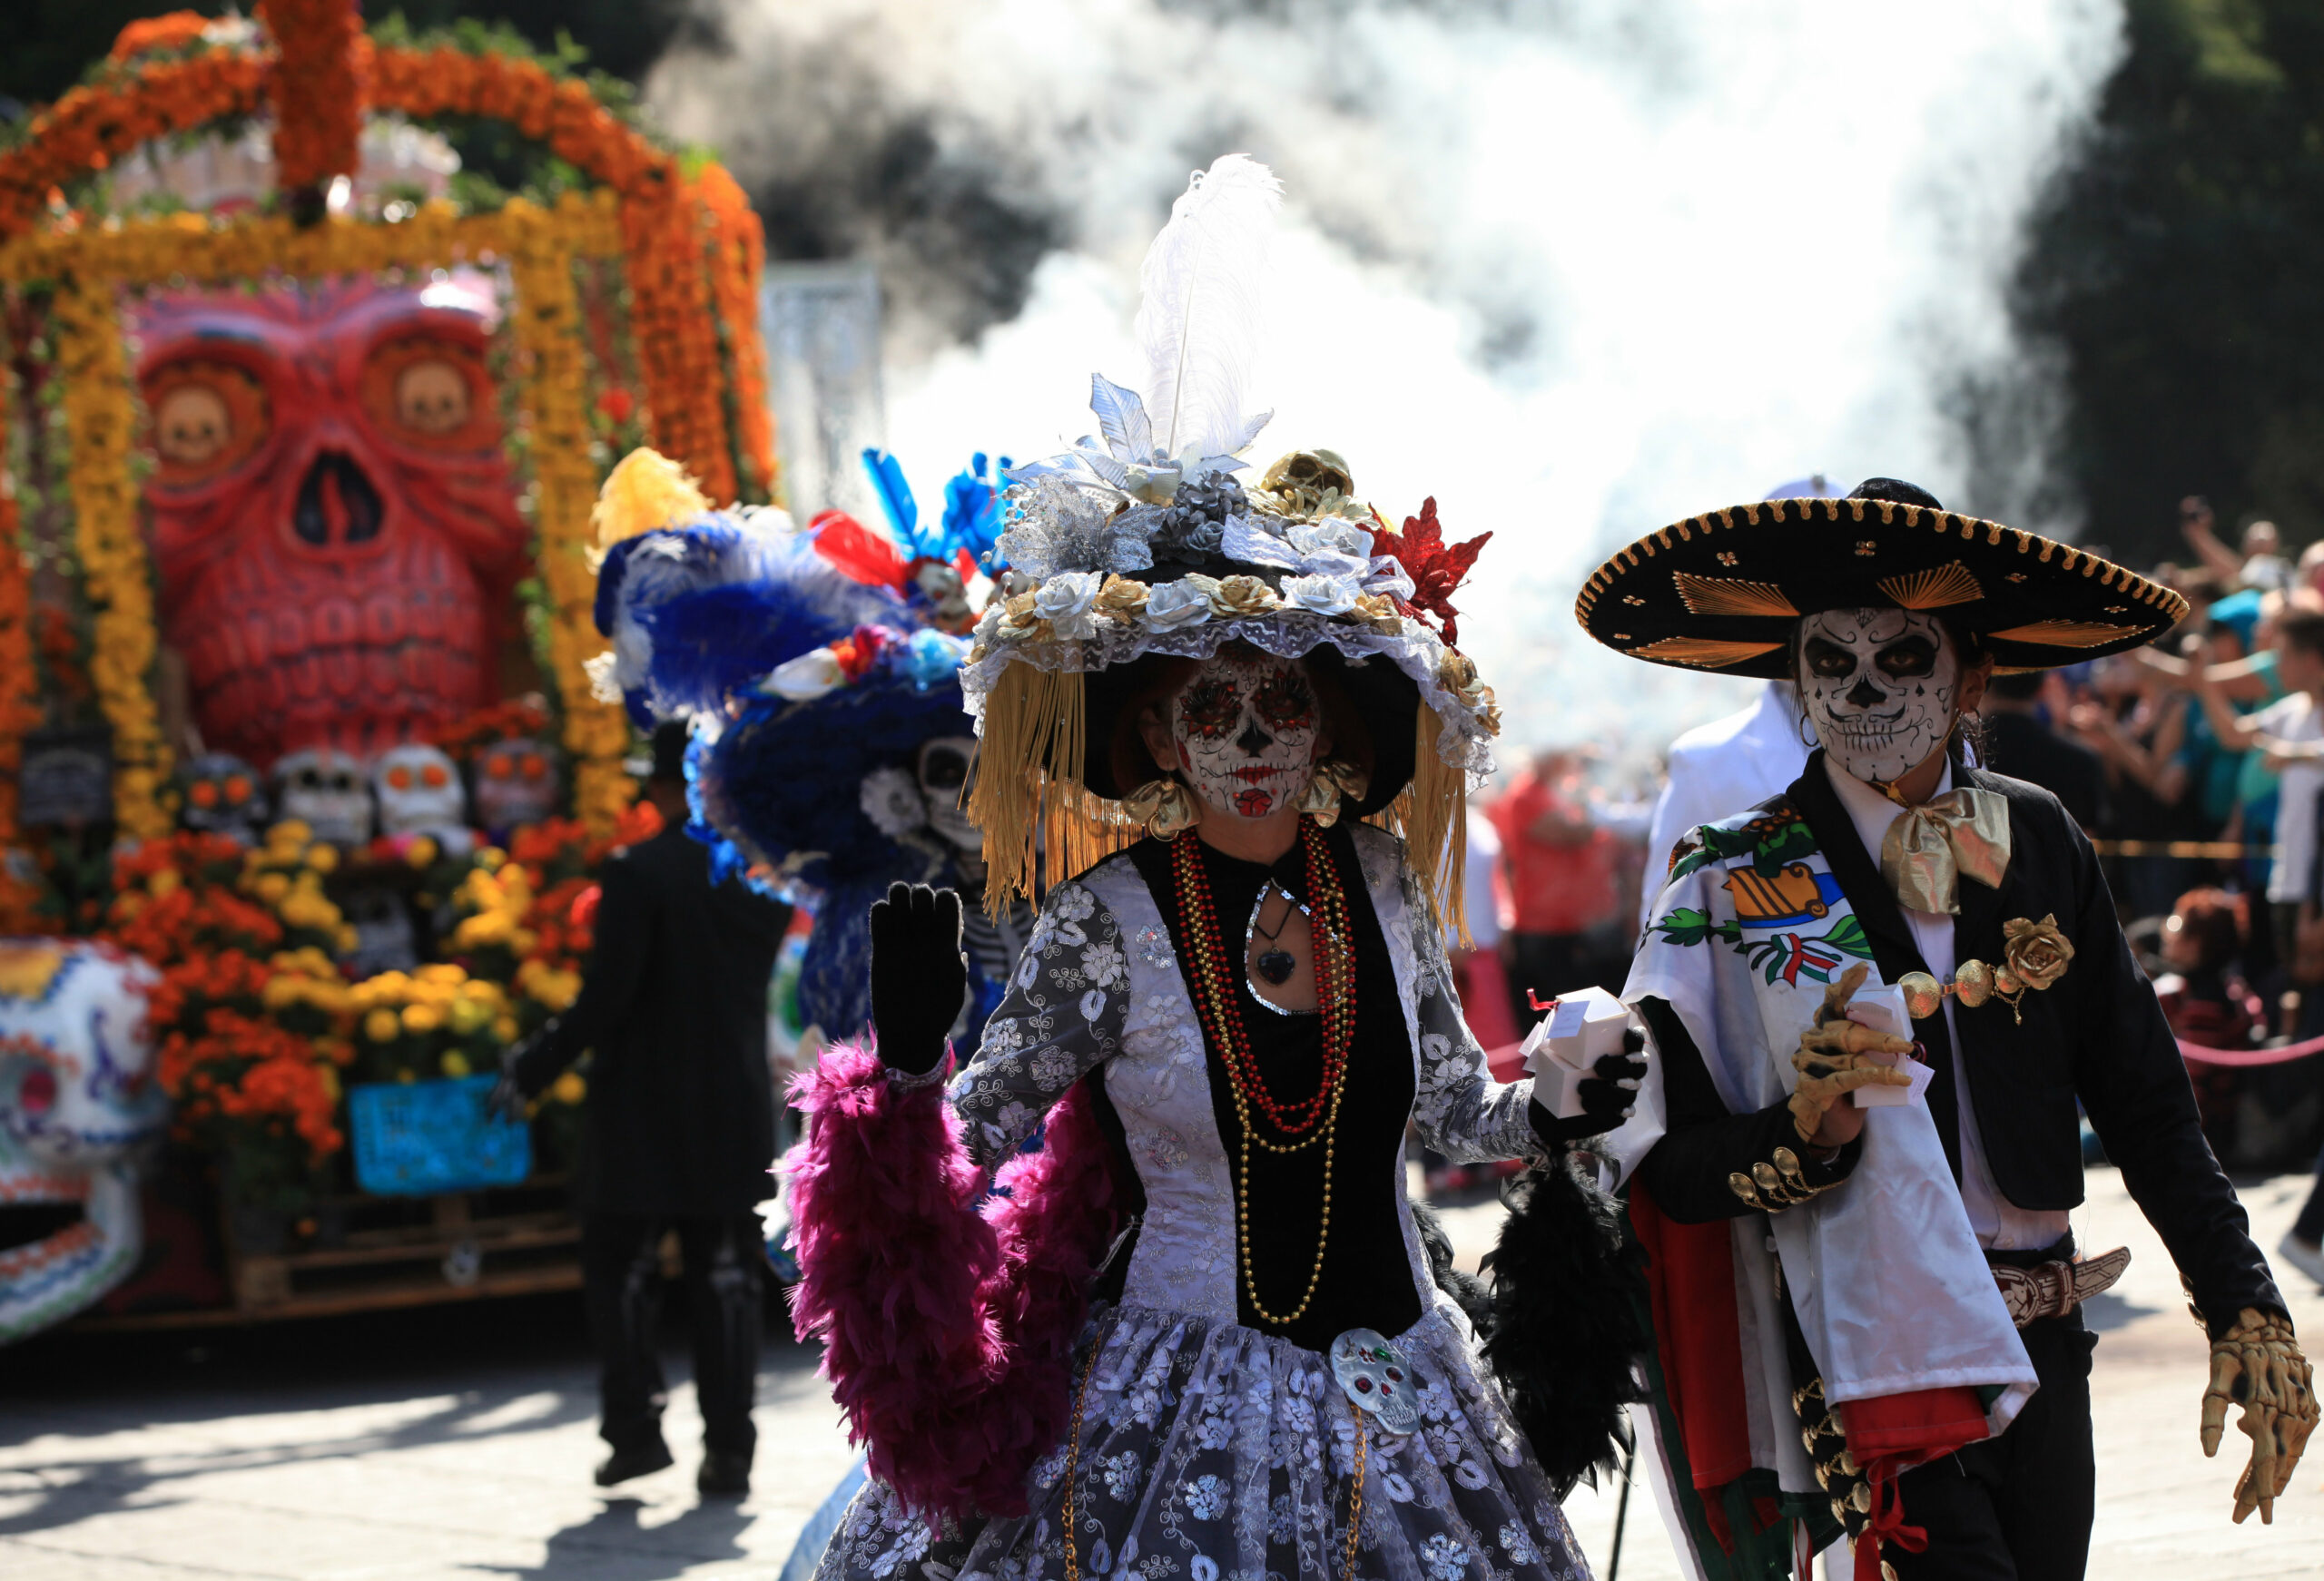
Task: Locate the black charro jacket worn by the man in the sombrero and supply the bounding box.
[1640,749,2284,1334]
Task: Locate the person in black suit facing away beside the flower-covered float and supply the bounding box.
[495,723,790,1495]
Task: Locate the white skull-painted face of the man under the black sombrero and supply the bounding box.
[1798,609,1962,786]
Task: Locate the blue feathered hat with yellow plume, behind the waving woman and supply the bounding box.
[590,451,974,899]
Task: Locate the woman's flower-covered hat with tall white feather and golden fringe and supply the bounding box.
[960,153,1502,907]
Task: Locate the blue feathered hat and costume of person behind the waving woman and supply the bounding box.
[597,454,1032,1046]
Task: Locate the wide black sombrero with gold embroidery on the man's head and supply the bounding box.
[1573,479,2187,679]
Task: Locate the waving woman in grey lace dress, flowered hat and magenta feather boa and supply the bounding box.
[771,156,1631,1581]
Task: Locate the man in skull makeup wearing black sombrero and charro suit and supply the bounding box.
[1576,479,2317,1581]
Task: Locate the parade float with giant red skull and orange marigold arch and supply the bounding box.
[0,0,776,1341]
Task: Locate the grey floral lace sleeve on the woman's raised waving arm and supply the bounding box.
[950,881,1129,1170]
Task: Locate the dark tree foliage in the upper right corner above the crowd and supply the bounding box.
[2013,0,2324,560]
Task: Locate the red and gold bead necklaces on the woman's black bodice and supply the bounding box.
[1171,819,1354,1328]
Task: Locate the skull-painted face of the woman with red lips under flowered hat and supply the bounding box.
[1171,653,1323,819]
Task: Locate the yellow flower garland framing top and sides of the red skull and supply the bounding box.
[0,189,635,837]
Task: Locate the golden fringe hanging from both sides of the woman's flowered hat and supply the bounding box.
[970,665,1469,947]
